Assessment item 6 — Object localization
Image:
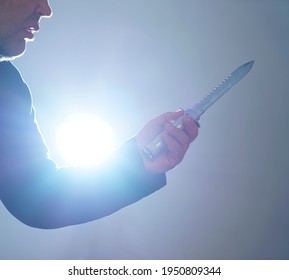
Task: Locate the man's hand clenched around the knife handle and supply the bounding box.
[136,110,198,173]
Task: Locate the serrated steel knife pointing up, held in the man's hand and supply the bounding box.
[143,60,254,160]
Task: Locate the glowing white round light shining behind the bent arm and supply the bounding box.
[57,114,115,166]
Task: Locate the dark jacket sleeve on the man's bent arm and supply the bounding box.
[0,63,166,228]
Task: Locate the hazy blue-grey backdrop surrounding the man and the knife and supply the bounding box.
[0,0,289,259]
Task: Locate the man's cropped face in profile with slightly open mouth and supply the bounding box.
[0,0,52,61]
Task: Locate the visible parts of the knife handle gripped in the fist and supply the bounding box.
[142,116,184,160]
